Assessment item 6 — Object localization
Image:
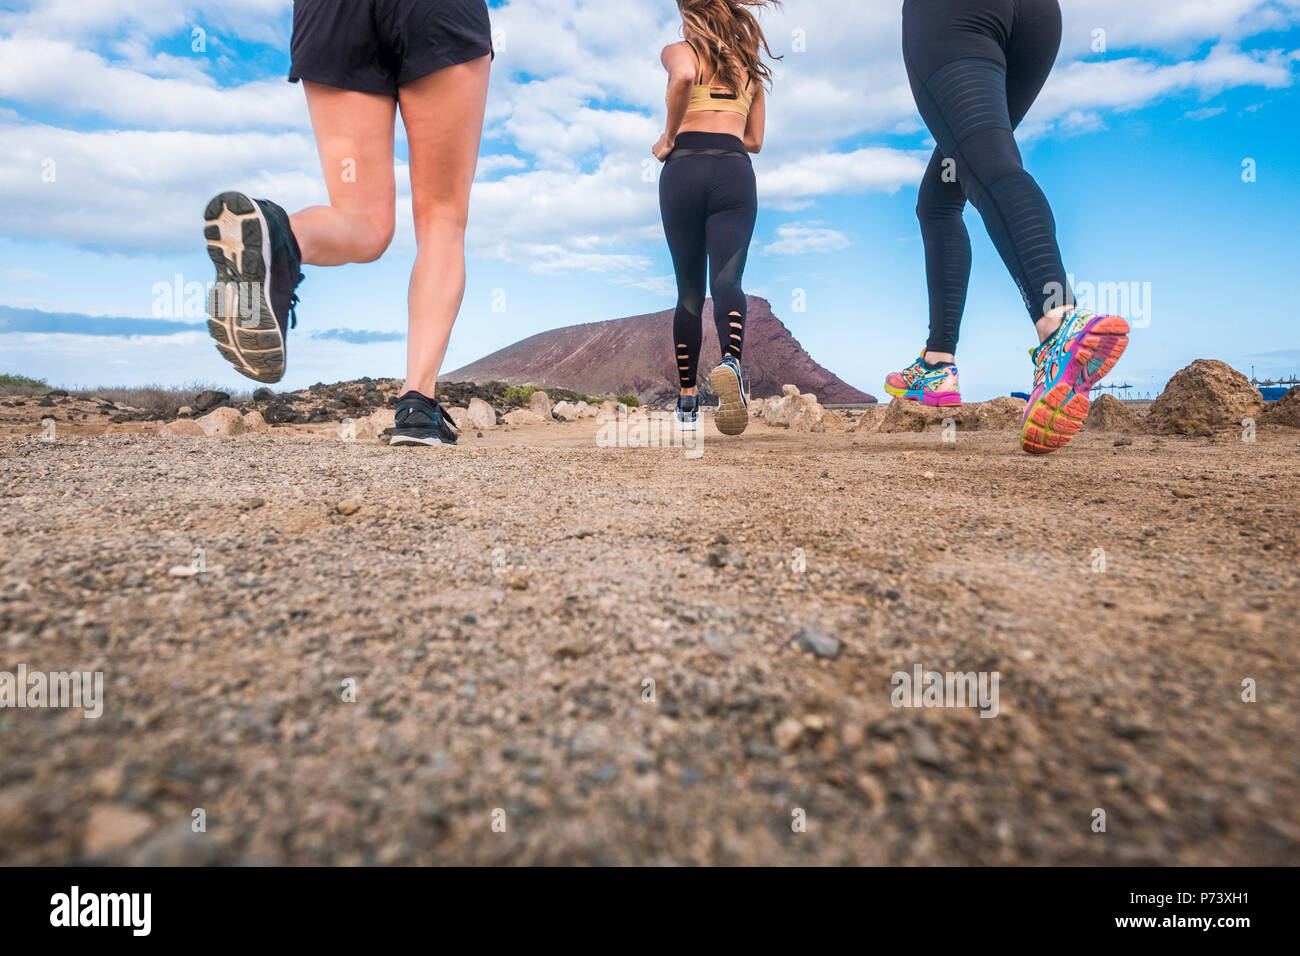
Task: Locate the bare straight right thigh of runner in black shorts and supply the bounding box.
[398,56,491,239]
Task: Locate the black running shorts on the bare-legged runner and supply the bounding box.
[289,0,493,96]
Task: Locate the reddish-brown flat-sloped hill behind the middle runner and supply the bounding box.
[441,295,876,405]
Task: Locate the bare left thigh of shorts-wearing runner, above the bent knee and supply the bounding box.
[303,81,397,246]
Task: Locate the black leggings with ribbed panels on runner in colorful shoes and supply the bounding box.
[902,0,1074,352]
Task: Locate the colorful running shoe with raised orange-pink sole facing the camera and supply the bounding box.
[1021,308,1128,455]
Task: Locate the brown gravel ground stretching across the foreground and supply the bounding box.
[0,423,1300,864]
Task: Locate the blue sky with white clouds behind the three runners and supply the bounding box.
[0,0,1300,399]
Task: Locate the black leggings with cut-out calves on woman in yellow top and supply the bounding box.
[659,133,758,389]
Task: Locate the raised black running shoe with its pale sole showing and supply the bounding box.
[203,193,303,382]
